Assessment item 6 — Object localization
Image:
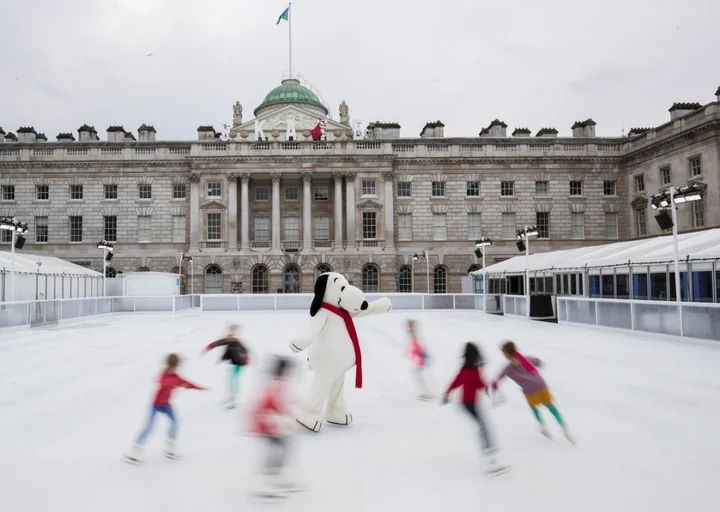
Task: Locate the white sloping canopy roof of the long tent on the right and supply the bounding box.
[473,229,720,275]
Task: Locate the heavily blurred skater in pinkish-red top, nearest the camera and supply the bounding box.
[250,357,299,497]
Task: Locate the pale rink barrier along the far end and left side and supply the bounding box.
[0,293,483,328]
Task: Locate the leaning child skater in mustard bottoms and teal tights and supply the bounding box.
[491,341,574,443]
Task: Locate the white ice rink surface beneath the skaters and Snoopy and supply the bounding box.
[0,311,720,512]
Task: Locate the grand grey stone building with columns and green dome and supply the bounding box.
[0,79,720,293]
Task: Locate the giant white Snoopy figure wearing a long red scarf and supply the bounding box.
[290,272,392,432]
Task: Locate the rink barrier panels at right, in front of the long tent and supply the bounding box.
[557,297,720,341]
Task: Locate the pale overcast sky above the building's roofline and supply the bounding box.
[0,0,720,140]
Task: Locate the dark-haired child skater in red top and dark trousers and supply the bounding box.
[442,342,509,474]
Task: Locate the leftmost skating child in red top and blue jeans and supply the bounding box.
[125,354,205,463]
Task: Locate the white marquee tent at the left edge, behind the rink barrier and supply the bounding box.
[0,252,102,302]
